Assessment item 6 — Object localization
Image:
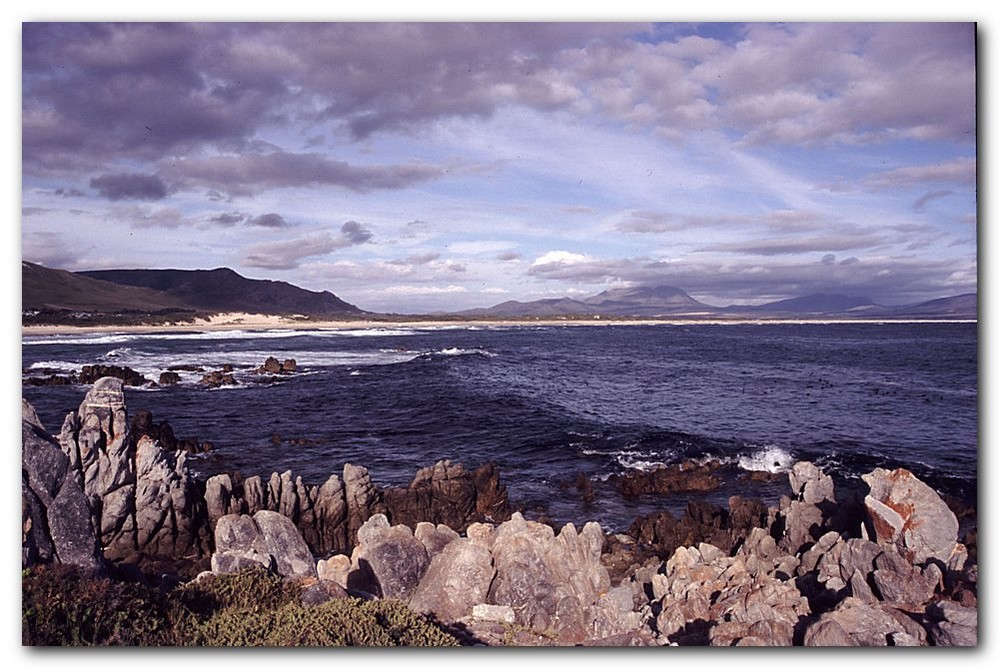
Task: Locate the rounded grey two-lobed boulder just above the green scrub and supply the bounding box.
[212,511,316,576]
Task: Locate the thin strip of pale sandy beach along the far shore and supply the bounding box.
[21,313,978,338]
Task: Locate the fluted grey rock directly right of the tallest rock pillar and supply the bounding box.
[134,436,207,558]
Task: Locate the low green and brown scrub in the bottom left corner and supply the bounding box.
[21,566,459,647]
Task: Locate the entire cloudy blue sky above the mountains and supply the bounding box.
[21,21,978,313]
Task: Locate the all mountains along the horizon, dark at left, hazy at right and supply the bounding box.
[21,262,978,319]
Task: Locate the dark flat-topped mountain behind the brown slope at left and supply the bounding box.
[77,268,364,316]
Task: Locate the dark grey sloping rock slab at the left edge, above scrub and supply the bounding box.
[21,399,104,573]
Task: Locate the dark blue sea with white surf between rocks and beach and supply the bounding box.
[22,323,978,528]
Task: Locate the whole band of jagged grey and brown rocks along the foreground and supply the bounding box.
[22,376,978,646]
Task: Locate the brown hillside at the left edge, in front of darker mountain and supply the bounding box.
[21,262,188,312]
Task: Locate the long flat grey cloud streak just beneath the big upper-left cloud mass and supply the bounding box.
[171,151,444,195]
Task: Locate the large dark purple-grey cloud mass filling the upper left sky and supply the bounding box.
[22,23,637,172]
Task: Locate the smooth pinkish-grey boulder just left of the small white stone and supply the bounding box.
[409,537,494,622]
